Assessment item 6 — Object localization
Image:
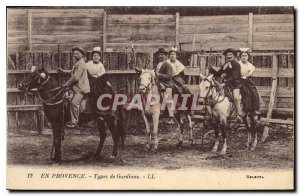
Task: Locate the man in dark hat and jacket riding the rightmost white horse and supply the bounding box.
[209,48,243,122]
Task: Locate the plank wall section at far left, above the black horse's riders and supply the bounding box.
[8,9,103,52]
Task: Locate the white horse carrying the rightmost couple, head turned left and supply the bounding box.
[199,74,257,155]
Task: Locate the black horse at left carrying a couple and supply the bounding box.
[18,66,125,162]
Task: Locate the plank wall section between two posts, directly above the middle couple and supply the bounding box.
[107,15,175,53]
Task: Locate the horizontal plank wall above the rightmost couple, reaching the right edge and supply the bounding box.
[179,13,294,51]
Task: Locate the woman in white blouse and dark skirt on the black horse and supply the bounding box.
[86,46,113,113]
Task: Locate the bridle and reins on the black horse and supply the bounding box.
[24,72,65,106]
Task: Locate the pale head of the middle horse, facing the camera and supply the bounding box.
[136,69,155,93]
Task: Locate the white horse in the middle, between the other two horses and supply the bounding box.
[136,69,193,151]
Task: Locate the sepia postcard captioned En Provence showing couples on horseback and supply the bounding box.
[6,6,296,190]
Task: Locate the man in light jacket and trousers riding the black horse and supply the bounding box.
[58,46,90,128]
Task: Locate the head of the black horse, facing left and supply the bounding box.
[18,66,49,91]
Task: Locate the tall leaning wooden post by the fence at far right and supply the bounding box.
[261,54,278,142]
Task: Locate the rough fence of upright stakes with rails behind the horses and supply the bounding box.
[7,52,294,130]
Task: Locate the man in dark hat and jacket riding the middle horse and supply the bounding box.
[154,48,174,119]
